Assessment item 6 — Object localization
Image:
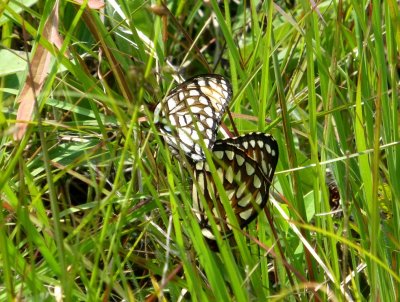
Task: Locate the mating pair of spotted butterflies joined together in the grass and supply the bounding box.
[155,74,278,239]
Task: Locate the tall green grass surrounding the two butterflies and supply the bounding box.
[0,0,400,301]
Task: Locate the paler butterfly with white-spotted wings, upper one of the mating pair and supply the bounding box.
[154,74,232,162]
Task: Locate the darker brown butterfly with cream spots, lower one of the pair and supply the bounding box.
[192,133,279,239]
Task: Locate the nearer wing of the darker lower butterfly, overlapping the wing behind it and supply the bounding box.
[192,136,276,239]
